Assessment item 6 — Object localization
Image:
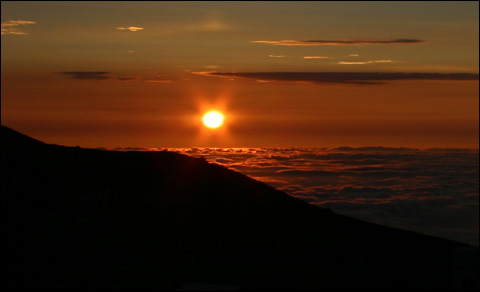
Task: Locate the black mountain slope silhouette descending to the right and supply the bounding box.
[1,126,472,291]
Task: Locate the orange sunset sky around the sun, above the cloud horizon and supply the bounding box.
[1,1,479,148]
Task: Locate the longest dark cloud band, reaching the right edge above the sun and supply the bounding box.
[201,72,478,85]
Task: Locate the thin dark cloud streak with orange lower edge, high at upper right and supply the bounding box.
[253,39,424,46]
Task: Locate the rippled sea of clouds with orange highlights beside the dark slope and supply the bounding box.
[111,147,479,245]
